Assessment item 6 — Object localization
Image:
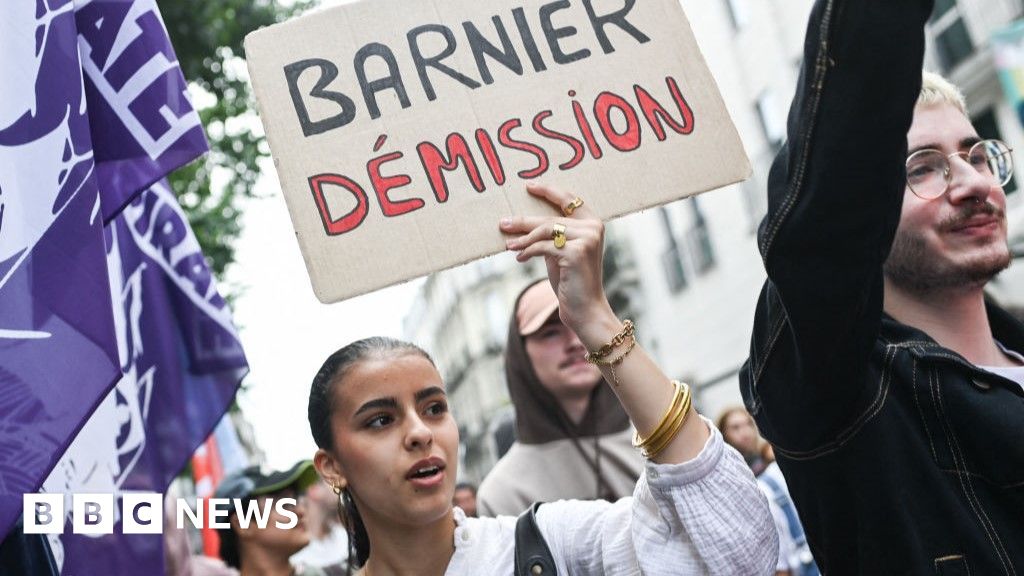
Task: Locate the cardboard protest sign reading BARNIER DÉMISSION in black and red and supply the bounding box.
[246,0,750,302]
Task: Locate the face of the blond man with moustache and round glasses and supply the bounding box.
[885,104,1010,293]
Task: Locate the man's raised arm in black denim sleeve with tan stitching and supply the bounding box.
[740,0,933,449]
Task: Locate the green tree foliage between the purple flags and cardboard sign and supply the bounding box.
[157,0,309,278]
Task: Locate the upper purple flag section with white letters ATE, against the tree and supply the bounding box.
[75,0,207,222]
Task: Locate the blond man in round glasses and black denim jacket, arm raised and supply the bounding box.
[740,0,1024,576]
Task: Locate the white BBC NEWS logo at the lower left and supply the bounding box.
[22,492,299,535]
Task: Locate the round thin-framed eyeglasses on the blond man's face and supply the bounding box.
[906,139,1014,200]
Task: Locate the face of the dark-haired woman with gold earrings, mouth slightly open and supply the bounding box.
[316,354,459,526]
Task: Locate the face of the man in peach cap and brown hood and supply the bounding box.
[525,314,601,400]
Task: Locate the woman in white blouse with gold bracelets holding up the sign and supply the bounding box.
[309,186,778,576]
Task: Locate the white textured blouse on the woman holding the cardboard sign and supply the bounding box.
[445,418,778,576]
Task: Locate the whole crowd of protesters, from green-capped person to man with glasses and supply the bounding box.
[155,0,1024,576]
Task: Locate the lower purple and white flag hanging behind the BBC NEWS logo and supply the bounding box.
[43,183,248,575]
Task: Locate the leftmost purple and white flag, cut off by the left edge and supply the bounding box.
[0,0,121,536]
